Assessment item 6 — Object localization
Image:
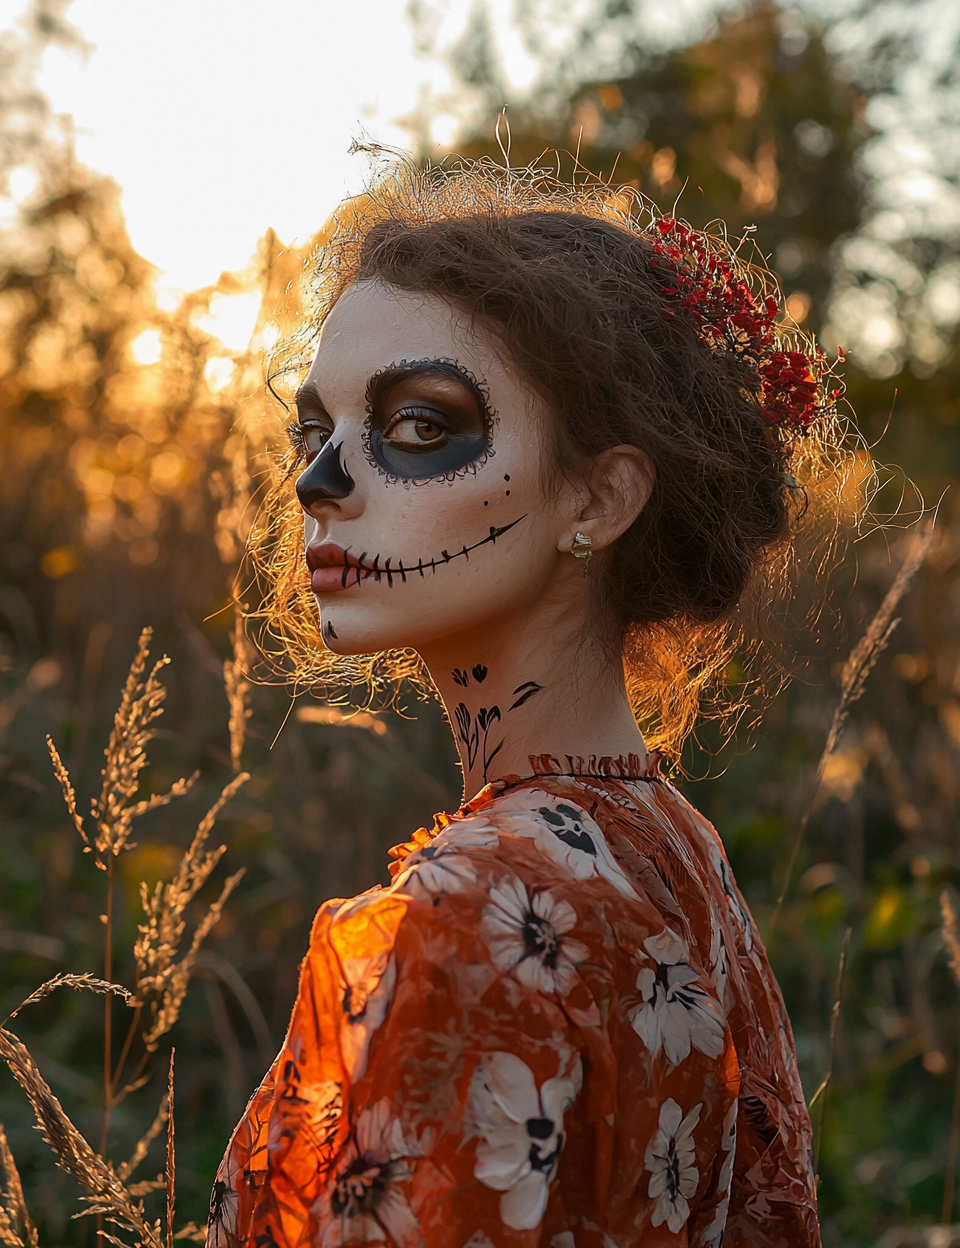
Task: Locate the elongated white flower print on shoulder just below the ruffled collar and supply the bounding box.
[489,789,637,901]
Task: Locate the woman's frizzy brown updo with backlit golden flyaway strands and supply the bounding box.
[250,161,851,755]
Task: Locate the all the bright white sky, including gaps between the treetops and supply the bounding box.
[11,0,960,361]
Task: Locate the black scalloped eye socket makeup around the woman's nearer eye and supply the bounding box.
[363,359,494,484]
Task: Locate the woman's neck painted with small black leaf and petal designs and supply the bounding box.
[421,591,645,800]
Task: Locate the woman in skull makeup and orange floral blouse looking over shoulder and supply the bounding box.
[208,165,840,1248]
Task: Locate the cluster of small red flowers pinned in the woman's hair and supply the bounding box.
[649,217,841,436]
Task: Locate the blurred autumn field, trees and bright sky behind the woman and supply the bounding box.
[0,0,960,1248]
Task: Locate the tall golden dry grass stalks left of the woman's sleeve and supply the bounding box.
[0,629,248,1248]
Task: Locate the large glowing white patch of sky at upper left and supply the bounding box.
[31,0,494,290]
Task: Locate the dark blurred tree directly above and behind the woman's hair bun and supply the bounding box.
[457,5,866,324]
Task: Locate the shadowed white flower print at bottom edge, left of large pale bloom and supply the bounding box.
[311,1099,423,1248]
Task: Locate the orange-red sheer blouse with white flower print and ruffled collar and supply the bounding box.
[207,755,820,1248]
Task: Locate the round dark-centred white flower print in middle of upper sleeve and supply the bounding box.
[481,876,588,995]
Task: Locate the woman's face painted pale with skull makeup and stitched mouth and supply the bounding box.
[295,282,578,654]
